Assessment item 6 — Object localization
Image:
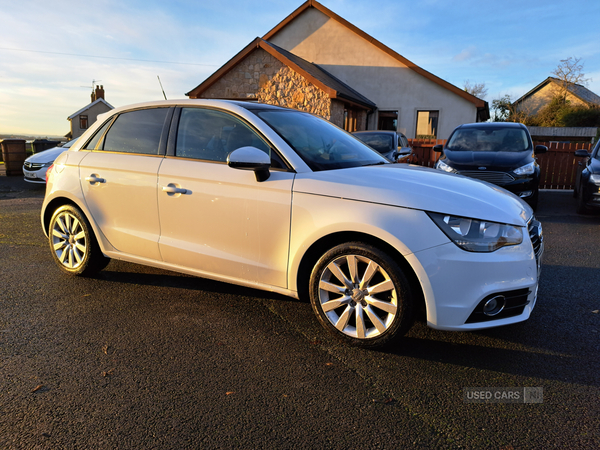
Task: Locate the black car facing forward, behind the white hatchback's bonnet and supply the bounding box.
[433,122,548,209]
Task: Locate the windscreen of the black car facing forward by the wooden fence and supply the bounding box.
[446,127,532,152]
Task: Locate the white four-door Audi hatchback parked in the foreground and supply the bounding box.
[41,100,543,347]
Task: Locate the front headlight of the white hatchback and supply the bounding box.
[427,213,523,252]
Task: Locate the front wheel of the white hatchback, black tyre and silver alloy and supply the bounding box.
[310,242,414,348]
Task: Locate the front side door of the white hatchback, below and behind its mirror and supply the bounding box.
[158,108,294,287]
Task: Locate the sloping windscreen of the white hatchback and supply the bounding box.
[255,110,388,172]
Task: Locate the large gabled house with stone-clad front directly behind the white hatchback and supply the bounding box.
[186,0,489,139]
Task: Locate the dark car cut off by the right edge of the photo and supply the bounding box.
[574,141,600,214]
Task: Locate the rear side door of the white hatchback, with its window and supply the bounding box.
[79,108,172,261]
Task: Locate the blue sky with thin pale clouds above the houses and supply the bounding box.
[0,0,600,136]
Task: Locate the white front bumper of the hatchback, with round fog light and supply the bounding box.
[407,219,544,331]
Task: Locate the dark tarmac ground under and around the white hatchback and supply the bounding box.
[0,170,600,450]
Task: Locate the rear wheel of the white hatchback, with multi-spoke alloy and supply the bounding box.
[48,205,110,276]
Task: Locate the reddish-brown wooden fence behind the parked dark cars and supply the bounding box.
[409,139,592,189]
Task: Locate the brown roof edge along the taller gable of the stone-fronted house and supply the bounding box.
[263,0,489,116]
